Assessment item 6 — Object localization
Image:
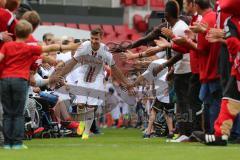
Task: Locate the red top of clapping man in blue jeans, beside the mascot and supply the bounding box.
[197,9,220,83]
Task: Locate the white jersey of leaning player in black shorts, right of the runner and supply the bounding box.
[142,59,170,103]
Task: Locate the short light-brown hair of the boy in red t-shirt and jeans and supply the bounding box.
[15,20,32,38]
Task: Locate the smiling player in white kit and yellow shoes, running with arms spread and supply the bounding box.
[54,28,132,139]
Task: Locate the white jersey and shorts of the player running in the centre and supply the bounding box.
[74,41,115,105]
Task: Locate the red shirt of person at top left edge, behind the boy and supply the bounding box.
[0,8,17,49]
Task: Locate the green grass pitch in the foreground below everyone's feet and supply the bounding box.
[0,129,240,160]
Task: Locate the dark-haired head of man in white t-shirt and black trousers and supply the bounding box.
[165,0,179,19]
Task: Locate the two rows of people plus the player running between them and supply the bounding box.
[0,0,240,149]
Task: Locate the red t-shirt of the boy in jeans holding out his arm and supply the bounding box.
[0,42,42,80]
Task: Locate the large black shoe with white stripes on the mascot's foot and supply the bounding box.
[192,131,227,146]
